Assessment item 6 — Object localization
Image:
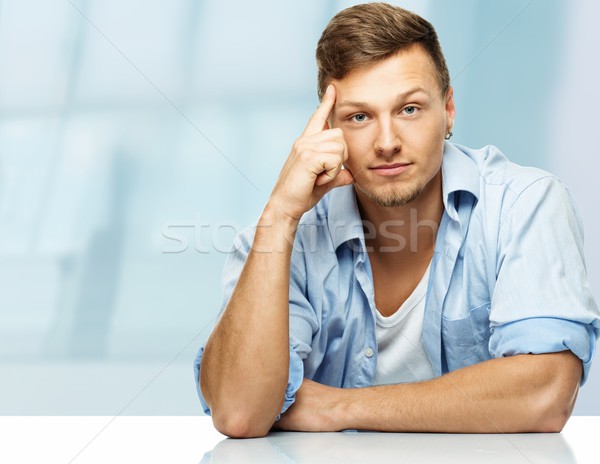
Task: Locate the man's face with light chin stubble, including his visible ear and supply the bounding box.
[331,45,454,206]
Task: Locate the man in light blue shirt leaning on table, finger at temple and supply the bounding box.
[195,3,600,437]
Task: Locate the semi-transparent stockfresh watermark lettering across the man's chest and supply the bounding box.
[161,208,439,254]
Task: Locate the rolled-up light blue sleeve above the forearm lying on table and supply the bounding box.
[489,176,600,385]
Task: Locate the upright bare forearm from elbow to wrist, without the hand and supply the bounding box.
[200,206,297,435]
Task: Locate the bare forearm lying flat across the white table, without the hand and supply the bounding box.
[338,352,581,433]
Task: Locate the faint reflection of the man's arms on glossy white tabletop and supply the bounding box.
[201,431,577,464]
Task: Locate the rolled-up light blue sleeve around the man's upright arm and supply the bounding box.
[194,227,317,420]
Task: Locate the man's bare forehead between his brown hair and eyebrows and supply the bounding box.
[332,45,440,103]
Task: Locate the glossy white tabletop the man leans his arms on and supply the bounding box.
[0,416,600,464]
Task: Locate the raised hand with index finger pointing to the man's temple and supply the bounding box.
[269,85,354,220]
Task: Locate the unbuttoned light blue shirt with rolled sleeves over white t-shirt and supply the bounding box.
[194,142,600,414]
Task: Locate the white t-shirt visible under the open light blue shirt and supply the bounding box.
[373,266,435,385]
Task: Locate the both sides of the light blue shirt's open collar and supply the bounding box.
[327,142,479,249]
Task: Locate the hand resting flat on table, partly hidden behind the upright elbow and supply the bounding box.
[273,379,347,432]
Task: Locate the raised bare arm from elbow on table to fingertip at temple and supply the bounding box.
[200,85,354,436]
